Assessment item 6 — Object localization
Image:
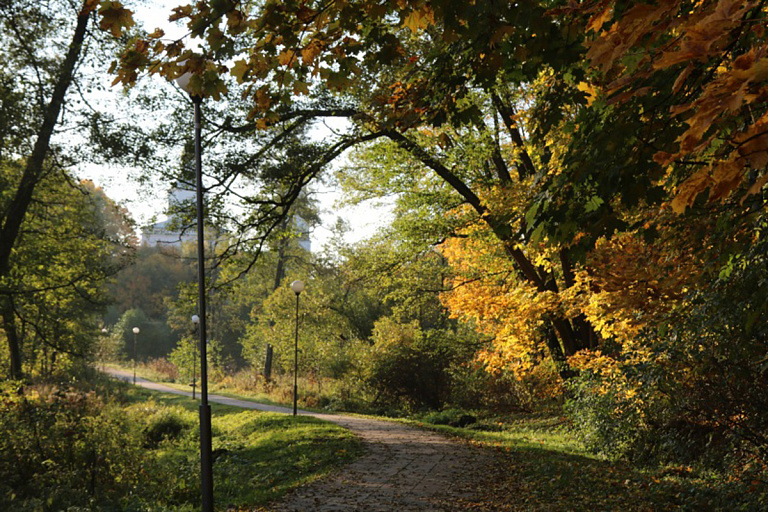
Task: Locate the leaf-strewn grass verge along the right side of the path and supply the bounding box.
[109,368,768,512]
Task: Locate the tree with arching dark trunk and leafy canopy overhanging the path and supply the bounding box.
[111,2,612,371]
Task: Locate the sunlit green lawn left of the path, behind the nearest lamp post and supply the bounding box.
[121,388,362,510]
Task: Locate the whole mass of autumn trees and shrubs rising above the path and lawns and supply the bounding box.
[0,0,768,510]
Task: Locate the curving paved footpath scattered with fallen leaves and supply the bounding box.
[106,369,498,512]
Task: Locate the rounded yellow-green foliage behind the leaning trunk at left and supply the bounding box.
[0,161,132,377]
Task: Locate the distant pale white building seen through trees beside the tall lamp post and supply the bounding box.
[141,183,200,248]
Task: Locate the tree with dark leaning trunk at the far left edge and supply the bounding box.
[0,0,132,378]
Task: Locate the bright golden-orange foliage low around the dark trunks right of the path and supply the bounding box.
[440,207,706,378]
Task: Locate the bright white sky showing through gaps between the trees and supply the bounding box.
[80,0,390,252]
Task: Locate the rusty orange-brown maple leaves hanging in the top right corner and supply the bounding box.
[565,0,768,213]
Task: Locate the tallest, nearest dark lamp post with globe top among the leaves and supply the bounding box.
[176,67,213,512]
